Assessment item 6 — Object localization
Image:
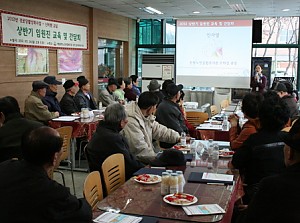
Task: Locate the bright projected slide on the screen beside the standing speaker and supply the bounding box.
[176,20,252,87]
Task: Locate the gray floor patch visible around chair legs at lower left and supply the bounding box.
[53,160,88,198]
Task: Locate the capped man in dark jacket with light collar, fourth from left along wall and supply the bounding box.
[74,76,97,110]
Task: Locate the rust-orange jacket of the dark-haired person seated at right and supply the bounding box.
[229,119,260,150]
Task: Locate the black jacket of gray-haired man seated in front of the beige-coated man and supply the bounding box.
[87,120,144,179]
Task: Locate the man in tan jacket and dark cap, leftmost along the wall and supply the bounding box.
[24,81,59,123]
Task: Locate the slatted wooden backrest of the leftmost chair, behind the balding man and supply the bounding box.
[56,126,73,166]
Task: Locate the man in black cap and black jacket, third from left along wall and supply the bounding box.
[60,80,80,115]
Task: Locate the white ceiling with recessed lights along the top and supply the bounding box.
[65,0,300,19]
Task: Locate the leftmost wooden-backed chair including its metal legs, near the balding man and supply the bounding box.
[50,126,76,195]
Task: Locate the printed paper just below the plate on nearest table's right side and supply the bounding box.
[182,204,225,215]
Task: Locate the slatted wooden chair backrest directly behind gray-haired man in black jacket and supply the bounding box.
[102,153,125,195]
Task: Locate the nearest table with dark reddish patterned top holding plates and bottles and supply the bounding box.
[94,166,240,223]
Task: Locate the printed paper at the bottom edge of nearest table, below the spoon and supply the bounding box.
[94,212,143,223]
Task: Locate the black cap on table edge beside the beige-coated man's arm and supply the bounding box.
[151,149,186,166]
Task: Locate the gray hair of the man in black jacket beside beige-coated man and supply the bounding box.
[104,103,127,125]
